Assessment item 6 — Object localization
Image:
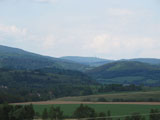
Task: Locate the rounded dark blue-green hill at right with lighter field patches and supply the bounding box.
[86,61,160,86]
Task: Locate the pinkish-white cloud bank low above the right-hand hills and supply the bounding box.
[85,34,160,58]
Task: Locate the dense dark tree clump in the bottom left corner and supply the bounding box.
[0,104,35,120]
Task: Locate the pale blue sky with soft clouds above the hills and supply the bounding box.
[0,0,160,59]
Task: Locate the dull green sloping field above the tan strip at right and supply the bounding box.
[56,91,160,102]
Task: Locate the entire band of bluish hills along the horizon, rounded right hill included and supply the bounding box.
[0,46,160,86]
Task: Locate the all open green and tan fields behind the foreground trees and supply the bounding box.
[11,91,160,117]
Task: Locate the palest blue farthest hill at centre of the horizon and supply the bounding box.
[61,56,114,67]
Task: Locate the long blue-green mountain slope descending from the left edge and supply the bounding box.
[0,45,88,71]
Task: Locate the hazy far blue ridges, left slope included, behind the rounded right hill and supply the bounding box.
[0,45,160,71]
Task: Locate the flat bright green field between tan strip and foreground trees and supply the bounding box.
[34,104,160,116]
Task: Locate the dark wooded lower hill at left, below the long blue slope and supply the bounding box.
[0,68,96,103]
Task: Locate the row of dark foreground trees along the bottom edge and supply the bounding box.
[0,104,160,120]
